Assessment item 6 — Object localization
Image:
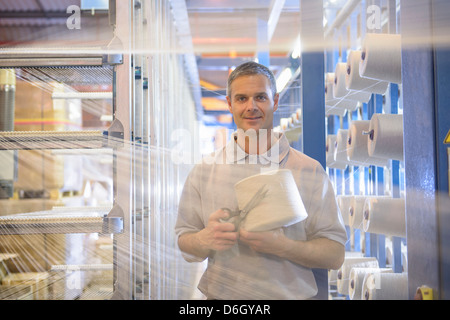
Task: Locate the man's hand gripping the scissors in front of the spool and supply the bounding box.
[197,209,239,251]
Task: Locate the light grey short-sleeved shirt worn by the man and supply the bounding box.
[175,134,347,300]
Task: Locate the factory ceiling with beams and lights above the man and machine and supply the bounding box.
[0,0,345,122]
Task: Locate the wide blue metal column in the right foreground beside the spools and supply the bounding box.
[400,0,440,298]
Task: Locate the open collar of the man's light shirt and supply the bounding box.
[225,132,290,164]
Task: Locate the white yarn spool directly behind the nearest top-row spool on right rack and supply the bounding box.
[345,50,389,95]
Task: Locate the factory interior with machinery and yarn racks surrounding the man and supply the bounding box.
[0,0,450,300]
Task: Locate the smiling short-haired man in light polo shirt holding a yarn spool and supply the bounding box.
[175,62,347,299]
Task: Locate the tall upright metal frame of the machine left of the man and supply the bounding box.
[107,0,202,300]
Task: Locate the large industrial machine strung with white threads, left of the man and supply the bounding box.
[0,1,199,299]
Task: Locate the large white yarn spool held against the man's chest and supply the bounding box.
[234,169,308,232]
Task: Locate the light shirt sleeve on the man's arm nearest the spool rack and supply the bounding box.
[306,165,347,245]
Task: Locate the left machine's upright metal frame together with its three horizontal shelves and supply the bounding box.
[0,0,202,300]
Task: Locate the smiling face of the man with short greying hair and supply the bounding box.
[227,75,278,132]
